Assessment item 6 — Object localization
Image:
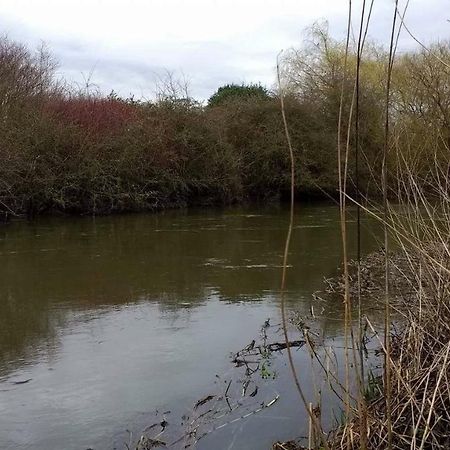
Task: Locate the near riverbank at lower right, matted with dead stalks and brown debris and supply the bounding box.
[273,236,450,450]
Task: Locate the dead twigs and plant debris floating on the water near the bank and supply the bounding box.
[129,319,296,450]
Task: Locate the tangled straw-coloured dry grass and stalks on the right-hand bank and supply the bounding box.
[274,156,450,450]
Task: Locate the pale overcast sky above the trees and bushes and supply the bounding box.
[0,0,450,99]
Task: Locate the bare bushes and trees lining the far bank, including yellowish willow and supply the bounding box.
[0,27,450,216]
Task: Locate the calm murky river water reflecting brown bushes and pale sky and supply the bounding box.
[0,205,382,450]
